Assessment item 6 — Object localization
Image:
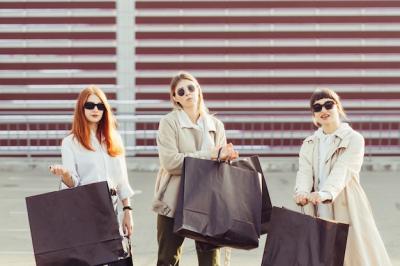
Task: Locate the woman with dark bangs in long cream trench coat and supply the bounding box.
[294,89,392,266]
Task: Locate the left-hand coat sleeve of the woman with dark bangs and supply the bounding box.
[294,141,313,194]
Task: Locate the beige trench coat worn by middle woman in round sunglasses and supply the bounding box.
[153,109,226,217]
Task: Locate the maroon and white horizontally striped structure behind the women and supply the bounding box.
[0,0,400,156]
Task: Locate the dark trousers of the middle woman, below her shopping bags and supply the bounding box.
[157,215,220,266]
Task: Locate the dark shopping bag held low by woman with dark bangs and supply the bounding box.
[261,207,349,266]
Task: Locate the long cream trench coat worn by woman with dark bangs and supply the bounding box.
[295,123,392,266]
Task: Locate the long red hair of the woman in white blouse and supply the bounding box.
[71,85,124,157]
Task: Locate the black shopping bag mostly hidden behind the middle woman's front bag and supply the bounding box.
[232,156,272,235]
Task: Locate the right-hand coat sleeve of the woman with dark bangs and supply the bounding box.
[320,133,364,201]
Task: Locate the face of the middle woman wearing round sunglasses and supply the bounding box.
[174,79,199,109]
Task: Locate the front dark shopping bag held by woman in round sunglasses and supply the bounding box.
[174,157,262,249]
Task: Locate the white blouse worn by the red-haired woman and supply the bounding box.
[61,132,133,200]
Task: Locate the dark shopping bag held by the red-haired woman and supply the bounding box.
[26,182,124,266]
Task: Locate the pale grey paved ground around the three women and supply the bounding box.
[0,161,400,266]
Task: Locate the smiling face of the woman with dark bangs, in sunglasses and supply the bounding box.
[312,98,340,126]
